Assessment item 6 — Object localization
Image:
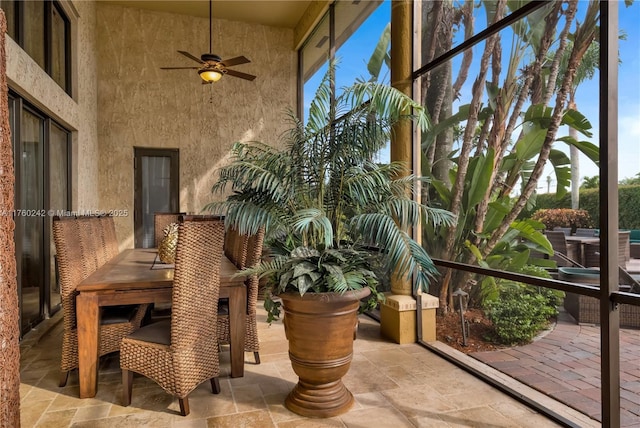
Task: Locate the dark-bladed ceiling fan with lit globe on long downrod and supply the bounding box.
[160,0,256,84]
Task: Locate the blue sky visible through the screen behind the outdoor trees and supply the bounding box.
[305,0,640,186]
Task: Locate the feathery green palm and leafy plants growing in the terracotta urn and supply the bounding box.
[207,66,453,320]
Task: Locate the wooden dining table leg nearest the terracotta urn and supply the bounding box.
[229,284,247,377]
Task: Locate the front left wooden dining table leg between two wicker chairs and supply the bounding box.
[76,294,100,398]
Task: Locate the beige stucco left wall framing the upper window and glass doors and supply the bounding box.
[5,1,99,210]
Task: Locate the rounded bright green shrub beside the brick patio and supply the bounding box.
[486,291,557,345]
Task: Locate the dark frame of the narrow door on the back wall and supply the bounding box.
[133,146,180,248]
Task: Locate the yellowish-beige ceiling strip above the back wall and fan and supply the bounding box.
[98,0,311,28]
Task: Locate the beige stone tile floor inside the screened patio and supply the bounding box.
[20,306,599,428]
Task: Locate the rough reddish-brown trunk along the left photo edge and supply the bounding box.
[0,9,20,428]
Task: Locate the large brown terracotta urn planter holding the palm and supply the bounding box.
[280,288,371,418]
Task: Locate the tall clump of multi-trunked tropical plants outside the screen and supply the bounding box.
[421,0,599,309]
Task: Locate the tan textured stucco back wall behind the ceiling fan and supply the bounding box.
[96,4,296,247]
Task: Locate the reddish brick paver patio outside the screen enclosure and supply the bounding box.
[471,310,640,427]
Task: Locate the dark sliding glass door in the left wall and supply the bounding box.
[9,94,71,334]
